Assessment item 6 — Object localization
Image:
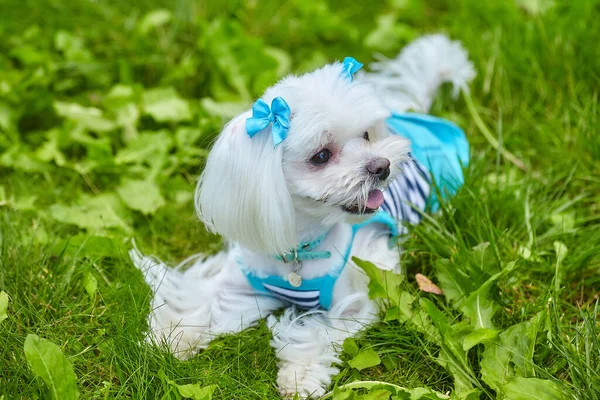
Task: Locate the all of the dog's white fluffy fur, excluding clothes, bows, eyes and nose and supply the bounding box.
[130,36,473,397]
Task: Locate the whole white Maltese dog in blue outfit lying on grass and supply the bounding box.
[130,35,474,397]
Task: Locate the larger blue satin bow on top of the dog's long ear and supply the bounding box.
[246,97,292,147]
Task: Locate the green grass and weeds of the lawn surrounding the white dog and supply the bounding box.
[0,0,600,399]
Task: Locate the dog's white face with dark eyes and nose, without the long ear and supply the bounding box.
[274,65,408,225]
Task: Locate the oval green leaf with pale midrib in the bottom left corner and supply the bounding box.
[24,334,79,400]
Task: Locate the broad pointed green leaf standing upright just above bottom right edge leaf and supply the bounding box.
[480,312,544,392]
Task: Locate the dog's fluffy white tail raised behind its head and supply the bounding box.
[363,34,475,113]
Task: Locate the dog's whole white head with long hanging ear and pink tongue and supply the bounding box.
[196,59,409,253]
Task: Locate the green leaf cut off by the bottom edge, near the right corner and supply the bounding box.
[502,377,568,400]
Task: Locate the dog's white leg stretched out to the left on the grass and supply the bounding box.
[130,249,282,359]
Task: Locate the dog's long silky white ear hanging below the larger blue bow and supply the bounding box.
[195,112,297,254]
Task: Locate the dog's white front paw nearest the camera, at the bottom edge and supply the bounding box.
[277,360,339,399]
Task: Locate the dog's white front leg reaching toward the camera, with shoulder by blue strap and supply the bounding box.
[268,225,399,397]
